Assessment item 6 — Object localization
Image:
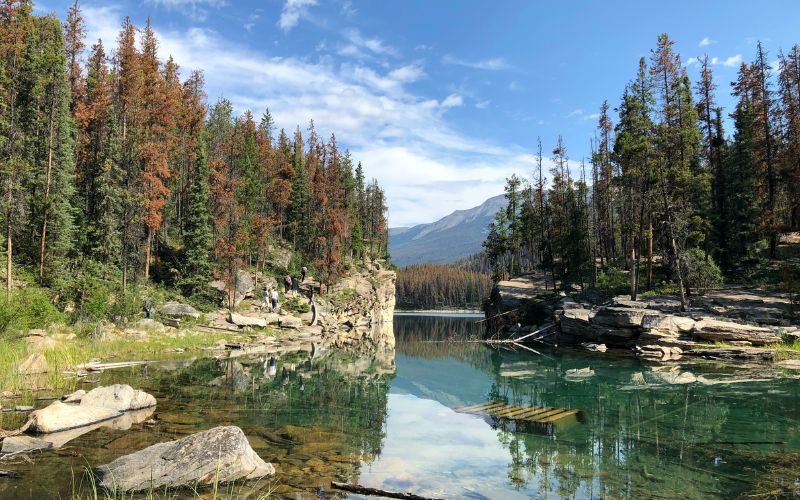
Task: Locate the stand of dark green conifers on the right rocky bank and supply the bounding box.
[485,34,800,304]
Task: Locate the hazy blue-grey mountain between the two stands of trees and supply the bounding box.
[389,194,506,267]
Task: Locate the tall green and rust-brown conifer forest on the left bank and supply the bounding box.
[0,0,387,316]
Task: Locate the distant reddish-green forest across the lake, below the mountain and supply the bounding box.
[397,264,492,309]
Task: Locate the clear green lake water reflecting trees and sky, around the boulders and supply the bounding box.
[0,316,800,499]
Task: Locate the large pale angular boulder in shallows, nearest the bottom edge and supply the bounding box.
[96,426,275,492]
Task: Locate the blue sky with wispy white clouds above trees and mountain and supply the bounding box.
[36,0,800,227]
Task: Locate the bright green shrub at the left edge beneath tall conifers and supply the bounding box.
[0,287,64,335]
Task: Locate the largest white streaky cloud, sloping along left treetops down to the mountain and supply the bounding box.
[84,6,533,226]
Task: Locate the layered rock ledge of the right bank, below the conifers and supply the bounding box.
[487,276,800,362]
